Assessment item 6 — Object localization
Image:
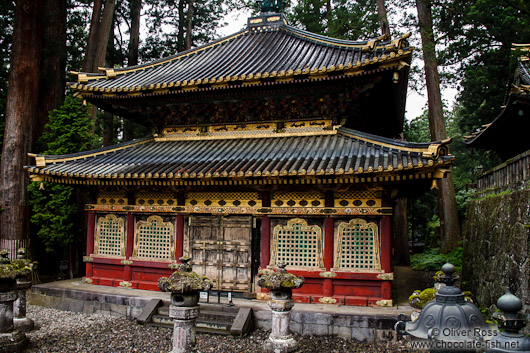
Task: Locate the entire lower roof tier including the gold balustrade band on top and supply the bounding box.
[26,120,454,185]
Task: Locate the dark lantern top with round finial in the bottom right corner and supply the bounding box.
[486,289,530,352]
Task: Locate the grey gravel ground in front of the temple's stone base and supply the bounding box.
[25,305,410,353]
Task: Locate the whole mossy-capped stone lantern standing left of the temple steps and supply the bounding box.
[158,257,212,353]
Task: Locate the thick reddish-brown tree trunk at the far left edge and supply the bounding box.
[0,0,43,255]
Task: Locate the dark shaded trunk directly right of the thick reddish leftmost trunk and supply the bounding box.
[33,0,66,148]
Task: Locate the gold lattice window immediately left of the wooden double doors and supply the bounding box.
[133,216,175,260]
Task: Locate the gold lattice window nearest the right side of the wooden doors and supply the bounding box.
[271,218,324,269]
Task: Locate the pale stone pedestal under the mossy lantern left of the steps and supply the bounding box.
[169,305,199,353]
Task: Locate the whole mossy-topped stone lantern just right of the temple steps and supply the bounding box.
[258,262,304,353]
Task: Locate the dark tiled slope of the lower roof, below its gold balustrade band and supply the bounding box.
[27,128,453,180]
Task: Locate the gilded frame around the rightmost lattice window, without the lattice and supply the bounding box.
[332,218,381,272]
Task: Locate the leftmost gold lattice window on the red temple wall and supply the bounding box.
[94,214,125,257]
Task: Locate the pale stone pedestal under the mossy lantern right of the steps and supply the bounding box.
[263,297,298,353]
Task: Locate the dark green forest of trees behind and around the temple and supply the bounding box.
[0,0,530,276]
